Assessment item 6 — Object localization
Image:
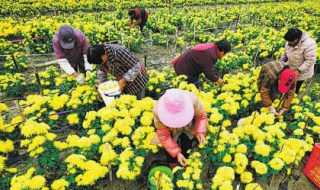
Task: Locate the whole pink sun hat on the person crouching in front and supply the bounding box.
[157,88,194,128]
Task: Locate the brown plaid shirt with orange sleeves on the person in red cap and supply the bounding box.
[258,61,296,108]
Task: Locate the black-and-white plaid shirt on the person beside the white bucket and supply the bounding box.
[98,44,149,95]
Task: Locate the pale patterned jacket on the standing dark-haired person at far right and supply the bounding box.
[280,33,317,81]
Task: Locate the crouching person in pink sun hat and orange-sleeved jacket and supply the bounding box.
[153,89,208,168]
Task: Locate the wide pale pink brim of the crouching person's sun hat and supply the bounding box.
[157,95,194,128]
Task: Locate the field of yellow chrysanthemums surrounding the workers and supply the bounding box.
[0,0,320,190]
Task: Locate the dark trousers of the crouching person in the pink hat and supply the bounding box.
[166,133,192,163]
